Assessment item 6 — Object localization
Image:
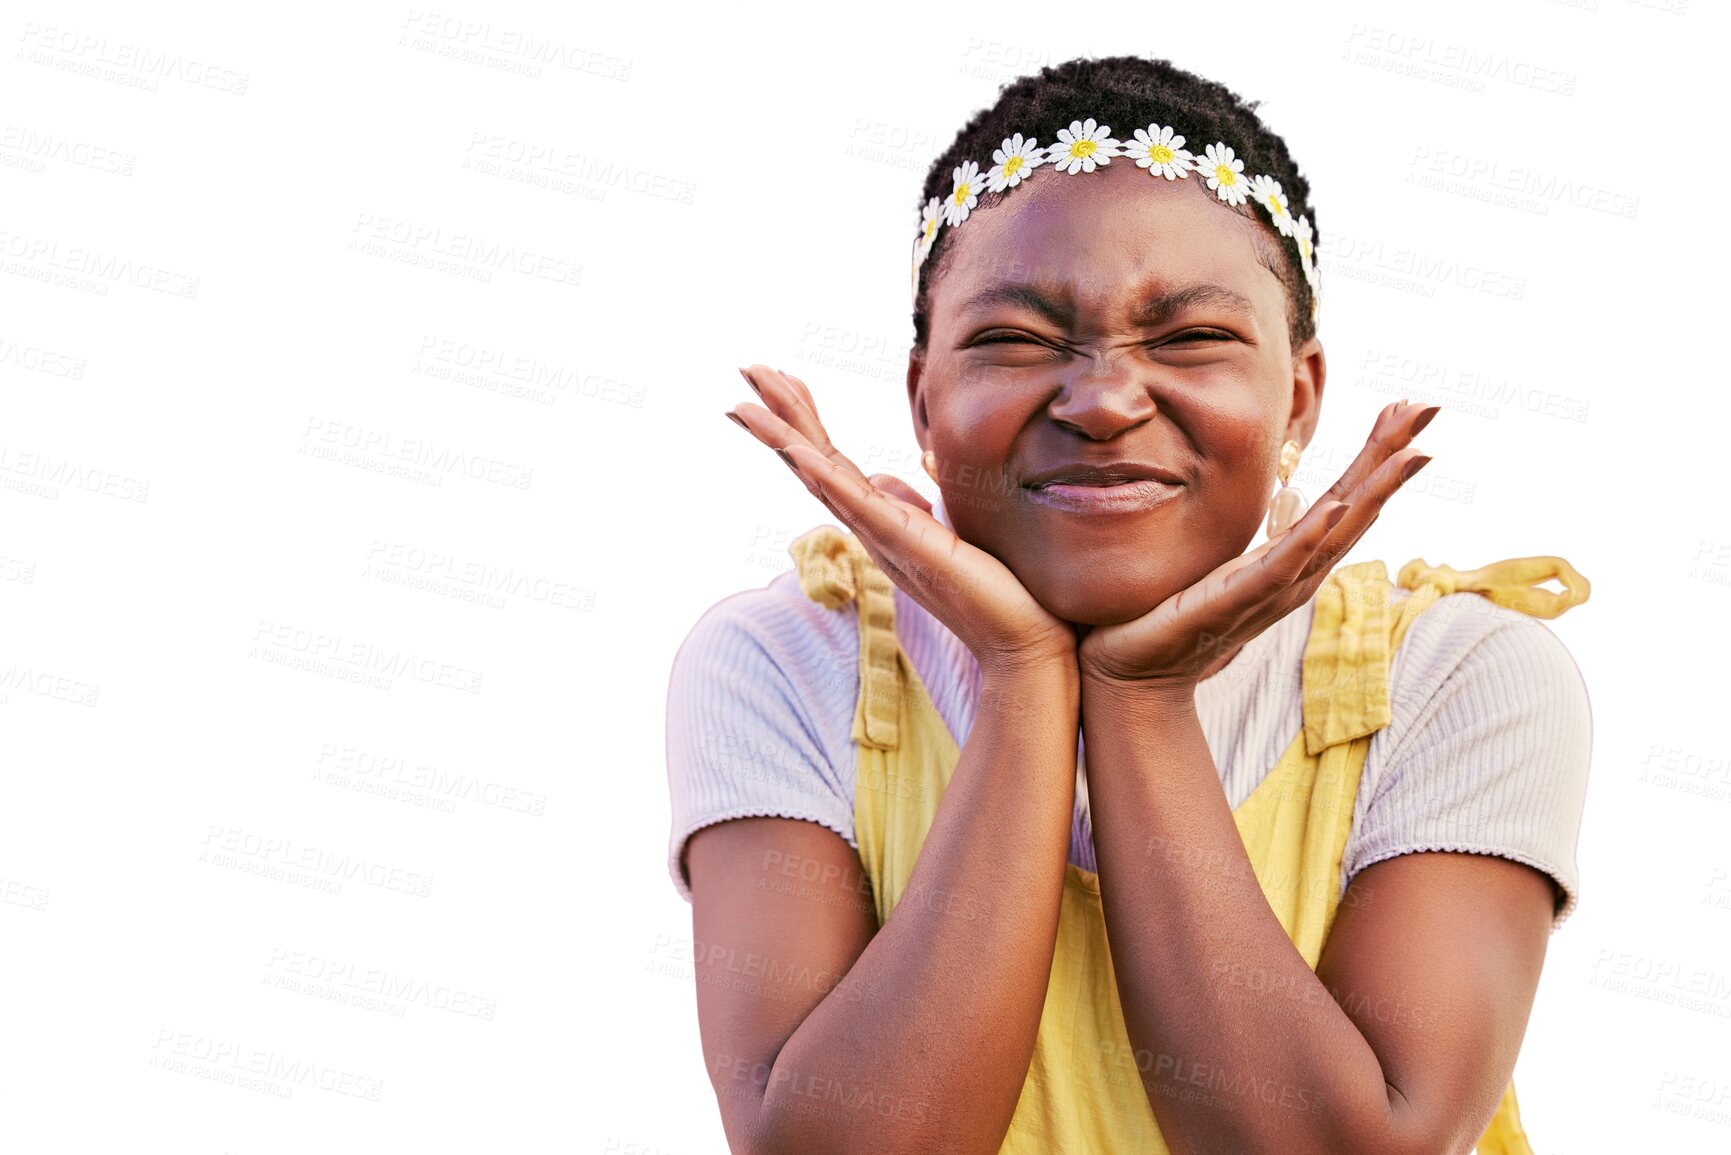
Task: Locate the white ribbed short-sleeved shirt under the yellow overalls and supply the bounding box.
[666,571,1591,928]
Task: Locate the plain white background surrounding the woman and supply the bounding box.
[0,0,1731,1155]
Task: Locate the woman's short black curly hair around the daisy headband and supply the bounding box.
[914,55,1321,355]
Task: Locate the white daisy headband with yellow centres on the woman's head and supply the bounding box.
[912,116,1322,320]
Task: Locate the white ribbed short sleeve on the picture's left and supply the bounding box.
[666,573,859,902]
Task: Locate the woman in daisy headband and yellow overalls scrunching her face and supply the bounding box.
[668,57,1591,1155]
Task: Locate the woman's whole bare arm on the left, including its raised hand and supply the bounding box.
[691,365,1080,1155]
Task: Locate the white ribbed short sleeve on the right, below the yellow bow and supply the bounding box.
[1343,592,1593,932]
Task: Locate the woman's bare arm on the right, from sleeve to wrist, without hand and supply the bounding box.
[1082,681,1554,1155]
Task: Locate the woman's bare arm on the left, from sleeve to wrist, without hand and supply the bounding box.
[687,655,1080,1155]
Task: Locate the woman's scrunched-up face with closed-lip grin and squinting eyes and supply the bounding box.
[907,161,1324,625]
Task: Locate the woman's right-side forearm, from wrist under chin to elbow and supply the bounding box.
[1082,681,1400,1155]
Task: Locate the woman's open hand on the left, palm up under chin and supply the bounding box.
[727,365,1077,672]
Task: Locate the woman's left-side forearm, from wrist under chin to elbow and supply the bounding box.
[760,660,1080,1153]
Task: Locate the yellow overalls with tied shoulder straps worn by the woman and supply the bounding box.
[788,525,1589,1155]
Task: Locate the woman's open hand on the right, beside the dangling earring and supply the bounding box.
[1078,402,1440,691]
